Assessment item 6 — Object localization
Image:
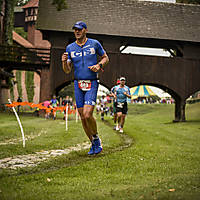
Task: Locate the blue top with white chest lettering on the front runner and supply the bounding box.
[66,38,105,80]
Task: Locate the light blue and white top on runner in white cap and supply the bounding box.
[114,85,131,103]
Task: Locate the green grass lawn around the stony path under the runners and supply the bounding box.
[0,103,200,200]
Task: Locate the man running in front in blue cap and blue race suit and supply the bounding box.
[62,21,109,155]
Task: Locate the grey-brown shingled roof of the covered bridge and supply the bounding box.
[37,0,200,42]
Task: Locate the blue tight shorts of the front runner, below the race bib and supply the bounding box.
[74,80,99,108]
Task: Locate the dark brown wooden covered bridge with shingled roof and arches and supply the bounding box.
[1,0,200,121]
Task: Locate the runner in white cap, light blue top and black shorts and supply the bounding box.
[114,77,131,133]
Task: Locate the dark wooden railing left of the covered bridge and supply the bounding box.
[0,45,50,65]
